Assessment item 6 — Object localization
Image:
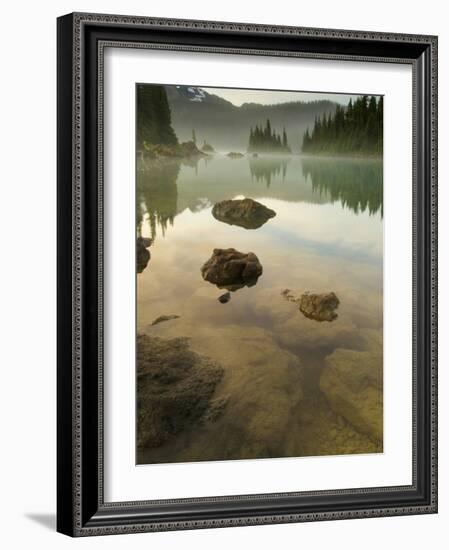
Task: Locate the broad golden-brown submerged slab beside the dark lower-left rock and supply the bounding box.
[138,326,304,464]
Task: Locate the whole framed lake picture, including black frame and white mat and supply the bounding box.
[57,13,437,536]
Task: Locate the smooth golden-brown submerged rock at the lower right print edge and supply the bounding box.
[320,349,383,449]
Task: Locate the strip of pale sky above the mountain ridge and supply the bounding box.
[204,88,358,106]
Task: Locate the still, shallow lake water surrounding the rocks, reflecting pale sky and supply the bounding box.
[137,155,383,463]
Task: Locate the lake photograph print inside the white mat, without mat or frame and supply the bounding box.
[136,83,383,464]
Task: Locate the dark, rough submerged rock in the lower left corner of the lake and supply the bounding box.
[137,335,225,448]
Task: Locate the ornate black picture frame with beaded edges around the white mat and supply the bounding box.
[57,13,437,536]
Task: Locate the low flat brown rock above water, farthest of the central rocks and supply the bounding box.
[212,198,276,229]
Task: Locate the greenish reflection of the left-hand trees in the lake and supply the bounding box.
[136,158,180,239]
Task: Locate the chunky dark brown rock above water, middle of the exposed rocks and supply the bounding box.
[201,248,262,291]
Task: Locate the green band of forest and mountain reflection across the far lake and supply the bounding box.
[137,155,383,239]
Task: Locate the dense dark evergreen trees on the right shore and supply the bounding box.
[302,96,383,155]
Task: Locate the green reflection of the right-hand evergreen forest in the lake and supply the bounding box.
[302,158,383,216]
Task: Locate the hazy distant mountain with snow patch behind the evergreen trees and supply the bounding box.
[165,86,337,153]
